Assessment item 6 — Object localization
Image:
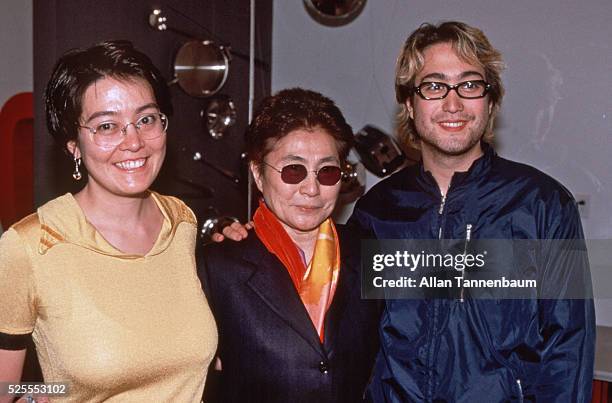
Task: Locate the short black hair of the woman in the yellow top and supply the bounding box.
[45,40,172,153]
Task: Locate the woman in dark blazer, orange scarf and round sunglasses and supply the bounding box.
[198,88,380,403]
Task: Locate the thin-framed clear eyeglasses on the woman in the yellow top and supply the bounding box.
[79,112,168,147]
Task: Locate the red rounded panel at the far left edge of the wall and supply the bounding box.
[0,92,34,228]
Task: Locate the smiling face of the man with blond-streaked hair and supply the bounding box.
[406,43,491,159]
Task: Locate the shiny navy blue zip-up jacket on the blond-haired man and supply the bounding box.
[349,144,595,403]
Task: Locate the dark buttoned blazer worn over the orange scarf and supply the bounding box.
[198,226,381,403]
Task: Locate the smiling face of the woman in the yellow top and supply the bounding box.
[67,77,166,197]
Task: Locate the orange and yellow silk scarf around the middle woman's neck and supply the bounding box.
[253,201,340,343]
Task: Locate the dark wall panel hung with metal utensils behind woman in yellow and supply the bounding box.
[33,0,272,227]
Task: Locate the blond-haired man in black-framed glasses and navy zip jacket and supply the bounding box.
[349,22,595,403]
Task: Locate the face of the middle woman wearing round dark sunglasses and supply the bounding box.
[251,128,340,239]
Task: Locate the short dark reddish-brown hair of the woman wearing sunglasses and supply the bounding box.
[246,88,353,165]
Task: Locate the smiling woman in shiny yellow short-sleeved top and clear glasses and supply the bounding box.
[0,41,217,402]
